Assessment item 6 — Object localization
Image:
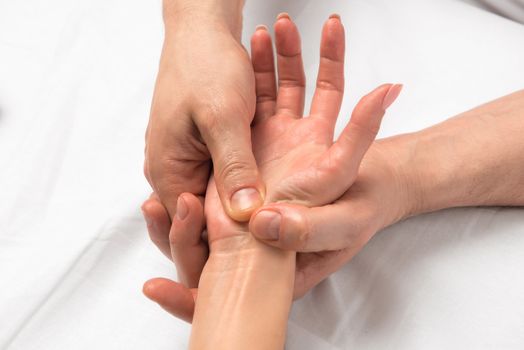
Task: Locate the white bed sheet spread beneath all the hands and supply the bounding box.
[0,0,524,350]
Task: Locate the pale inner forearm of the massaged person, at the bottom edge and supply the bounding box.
[190,238,295,350]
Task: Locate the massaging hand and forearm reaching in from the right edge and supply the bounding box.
[143,23,524,326]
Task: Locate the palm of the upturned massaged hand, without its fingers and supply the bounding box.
[205,114,332,246]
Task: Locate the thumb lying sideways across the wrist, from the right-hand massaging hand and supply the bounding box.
[249,201,379,252]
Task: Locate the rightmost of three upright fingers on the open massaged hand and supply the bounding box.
[310,15,345,131]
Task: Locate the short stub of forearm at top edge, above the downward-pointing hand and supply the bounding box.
[163,0,244,41]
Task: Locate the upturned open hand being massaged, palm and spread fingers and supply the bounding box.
[205,19,388,246]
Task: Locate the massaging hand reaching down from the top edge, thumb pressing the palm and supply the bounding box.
[144,1,265,221]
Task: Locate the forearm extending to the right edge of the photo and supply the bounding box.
[388,90,524,216]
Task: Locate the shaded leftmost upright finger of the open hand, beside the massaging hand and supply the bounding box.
[251,26,277,124]
